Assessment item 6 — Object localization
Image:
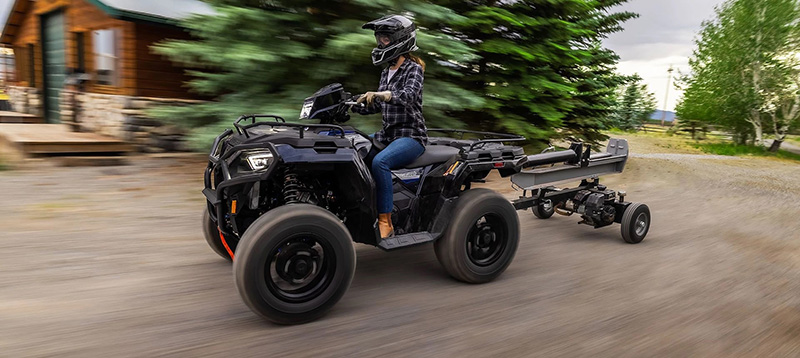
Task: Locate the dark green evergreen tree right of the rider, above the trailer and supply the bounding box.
[439,0,636,142]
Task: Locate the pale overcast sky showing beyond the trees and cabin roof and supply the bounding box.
[0,0,723,110]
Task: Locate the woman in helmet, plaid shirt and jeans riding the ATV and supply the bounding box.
[353,15,428,238]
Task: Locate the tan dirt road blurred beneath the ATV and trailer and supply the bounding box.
[0,138,800,357]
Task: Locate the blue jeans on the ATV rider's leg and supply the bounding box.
[372,137,425,214]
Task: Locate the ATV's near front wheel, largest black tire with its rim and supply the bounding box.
[233,204,356,324]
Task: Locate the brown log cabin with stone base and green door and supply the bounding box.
[0,0,213,150]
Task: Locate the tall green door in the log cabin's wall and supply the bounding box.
[42,11,67,123]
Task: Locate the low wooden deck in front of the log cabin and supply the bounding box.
[0,123,133,162]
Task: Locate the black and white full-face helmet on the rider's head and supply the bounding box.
[361,15,419,66]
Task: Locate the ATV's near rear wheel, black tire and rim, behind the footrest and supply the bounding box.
[434,189,519,283]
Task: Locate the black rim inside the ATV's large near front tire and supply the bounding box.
[264,234,336,303]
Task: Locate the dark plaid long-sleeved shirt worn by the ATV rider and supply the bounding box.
[353,59,428,145]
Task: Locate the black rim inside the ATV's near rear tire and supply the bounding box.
[466,214,508,267]
